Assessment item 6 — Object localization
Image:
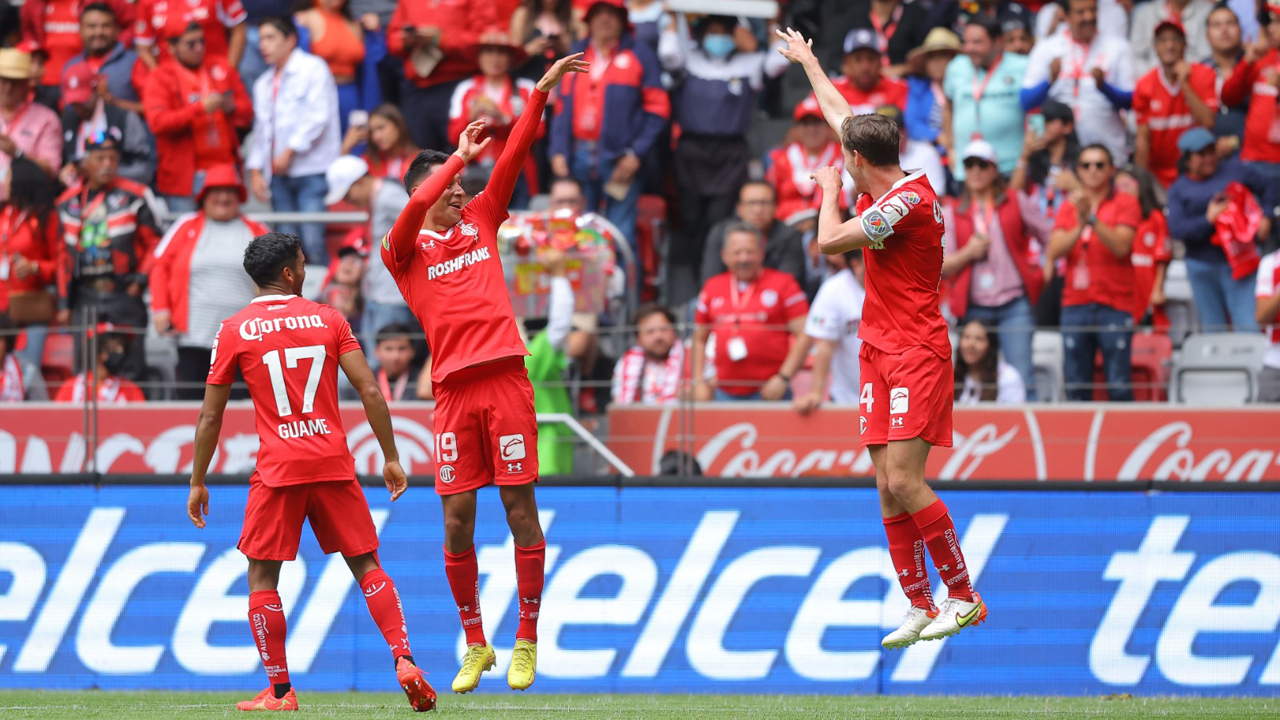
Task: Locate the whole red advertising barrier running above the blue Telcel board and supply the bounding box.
[0,401,1280,479]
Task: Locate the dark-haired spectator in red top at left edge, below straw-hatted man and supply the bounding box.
[0,158,67,366]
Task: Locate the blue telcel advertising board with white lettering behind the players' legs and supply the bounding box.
[0,487,1280,696]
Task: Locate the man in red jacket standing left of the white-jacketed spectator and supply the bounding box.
[143,23,253,213]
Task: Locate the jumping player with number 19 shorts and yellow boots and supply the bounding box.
[383,54,588,693]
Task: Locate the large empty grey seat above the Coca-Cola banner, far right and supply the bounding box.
[1170,333,1267,406]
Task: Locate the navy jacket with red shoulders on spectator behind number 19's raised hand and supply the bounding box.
[549,35,671,167]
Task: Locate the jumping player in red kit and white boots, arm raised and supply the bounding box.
[778,28,987,648]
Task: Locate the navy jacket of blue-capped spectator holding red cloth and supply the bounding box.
[1169,156,1280,261]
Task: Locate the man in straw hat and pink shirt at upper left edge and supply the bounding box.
[0,47,63,181]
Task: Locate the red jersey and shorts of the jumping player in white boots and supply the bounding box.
[856,170,954,447]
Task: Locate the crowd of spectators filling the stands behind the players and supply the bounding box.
[0,0,1280,413]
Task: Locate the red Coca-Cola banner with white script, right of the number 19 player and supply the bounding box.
[608,404,1280,482]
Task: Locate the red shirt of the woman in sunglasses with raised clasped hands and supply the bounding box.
[1053,192,1142,311]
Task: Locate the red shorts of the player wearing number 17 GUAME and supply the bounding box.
[237,475,378,560]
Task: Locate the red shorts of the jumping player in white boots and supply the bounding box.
[858,342,955,447]
